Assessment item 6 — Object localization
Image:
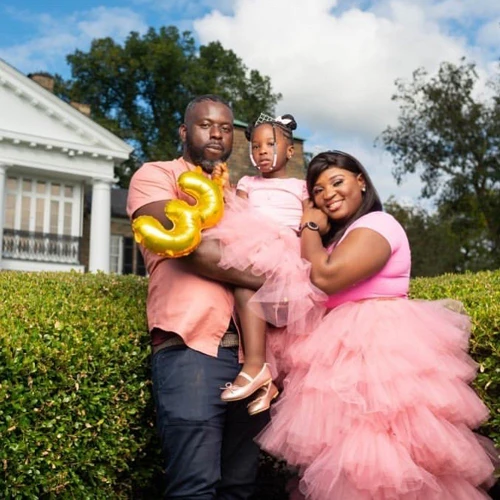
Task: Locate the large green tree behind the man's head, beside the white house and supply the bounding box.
[56,26,281,187]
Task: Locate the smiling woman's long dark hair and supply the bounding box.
[306,151,383,246]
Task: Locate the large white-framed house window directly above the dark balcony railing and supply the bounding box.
[4,176,80,236]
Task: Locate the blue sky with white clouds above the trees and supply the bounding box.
[0,0,500,201]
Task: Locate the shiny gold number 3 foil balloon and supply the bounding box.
[132,167,225,258]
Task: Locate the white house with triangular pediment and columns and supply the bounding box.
[0,59,133,272]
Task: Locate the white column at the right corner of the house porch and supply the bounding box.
[89,179,111,273]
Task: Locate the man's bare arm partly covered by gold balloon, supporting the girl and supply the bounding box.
[133,200,264,290]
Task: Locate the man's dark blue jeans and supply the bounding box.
[152,346,269,500]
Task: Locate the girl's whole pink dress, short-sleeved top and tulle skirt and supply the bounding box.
[203,176,327,382]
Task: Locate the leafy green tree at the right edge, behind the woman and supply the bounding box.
[380,60,500,268]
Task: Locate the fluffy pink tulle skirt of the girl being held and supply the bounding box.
[204,193,328,334]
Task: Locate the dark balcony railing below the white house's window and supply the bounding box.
[2,229,81,264]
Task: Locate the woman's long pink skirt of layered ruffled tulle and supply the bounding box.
[258,299,493,500]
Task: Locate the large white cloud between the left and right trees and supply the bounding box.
[193,0,497,203]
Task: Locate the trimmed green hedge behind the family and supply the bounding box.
[0,272,500,500]
